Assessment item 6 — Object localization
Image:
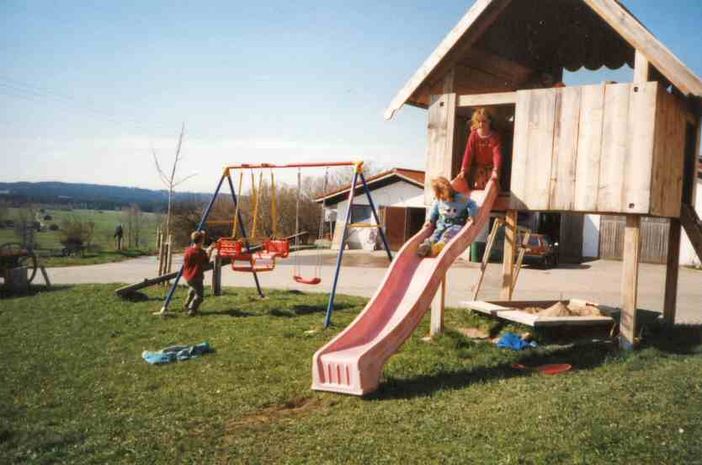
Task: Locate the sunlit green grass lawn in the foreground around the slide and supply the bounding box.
[0,285,702,464]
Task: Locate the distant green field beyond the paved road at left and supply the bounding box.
[0,207,160,266]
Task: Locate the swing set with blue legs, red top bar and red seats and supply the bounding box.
[158,161,392,328]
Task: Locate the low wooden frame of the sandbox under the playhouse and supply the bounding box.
[461,299,619,328]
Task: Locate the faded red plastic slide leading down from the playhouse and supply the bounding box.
[312,181,498,395]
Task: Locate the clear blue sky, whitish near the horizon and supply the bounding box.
[0,0,702,191]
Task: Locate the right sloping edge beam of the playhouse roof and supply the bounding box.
[584,0,702,96]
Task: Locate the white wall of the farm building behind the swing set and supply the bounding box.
[327,181,424,250]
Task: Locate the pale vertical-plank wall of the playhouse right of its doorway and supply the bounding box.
[511,82,684,216]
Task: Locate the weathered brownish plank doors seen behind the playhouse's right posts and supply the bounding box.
[600,215,670,263]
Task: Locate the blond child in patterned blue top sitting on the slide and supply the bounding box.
[417,176,478,257]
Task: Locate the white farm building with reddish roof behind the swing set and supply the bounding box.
[315,168,425,250]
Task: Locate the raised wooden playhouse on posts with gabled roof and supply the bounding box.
[385,0,702,348]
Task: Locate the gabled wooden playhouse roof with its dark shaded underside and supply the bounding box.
[385,0,702,119]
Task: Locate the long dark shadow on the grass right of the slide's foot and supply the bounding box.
[374,343,616,400]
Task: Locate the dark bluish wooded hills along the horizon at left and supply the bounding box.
[0,182,210,212]
